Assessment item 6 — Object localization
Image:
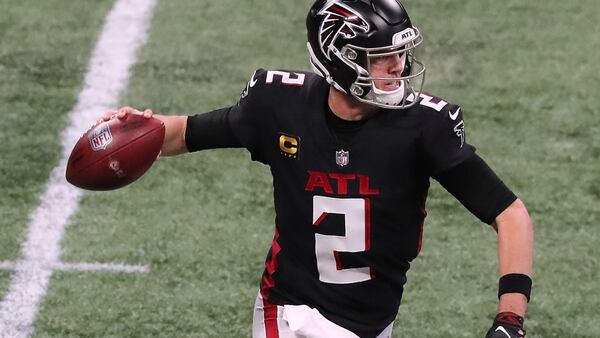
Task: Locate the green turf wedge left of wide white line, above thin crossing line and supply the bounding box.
[0,0,116,270]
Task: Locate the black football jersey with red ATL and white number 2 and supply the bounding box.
[192,70,474,337]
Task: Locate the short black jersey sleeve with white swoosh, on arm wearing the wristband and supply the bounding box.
[422,104,475,175]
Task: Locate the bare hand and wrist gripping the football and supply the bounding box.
[102,107,188,156]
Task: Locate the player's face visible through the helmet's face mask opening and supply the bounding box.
[369,53,406,92]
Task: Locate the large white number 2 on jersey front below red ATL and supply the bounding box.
[313,196,372,284]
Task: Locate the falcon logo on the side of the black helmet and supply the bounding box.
[318,1,369,60]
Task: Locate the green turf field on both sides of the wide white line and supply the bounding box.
[0,0,600,338]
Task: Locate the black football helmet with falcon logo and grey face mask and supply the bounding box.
[306,0,425,109]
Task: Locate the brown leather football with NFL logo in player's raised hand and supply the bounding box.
[66,114,165,190]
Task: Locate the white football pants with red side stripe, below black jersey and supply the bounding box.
[252,293,394,338]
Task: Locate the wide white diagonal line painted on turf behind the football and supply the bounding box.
[0,0,158,337]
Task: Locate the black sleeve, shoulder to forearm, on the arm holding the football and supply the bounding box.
[185,69,268,163]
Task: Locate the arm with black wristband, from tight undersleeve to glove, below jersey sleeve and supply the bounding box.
[436,154,533,338]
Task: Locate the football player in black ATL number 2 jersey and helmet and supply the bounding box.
[105,0,533,338]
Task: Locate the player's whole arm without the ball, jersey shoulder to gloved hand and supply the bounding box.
[423,104,533,338]
